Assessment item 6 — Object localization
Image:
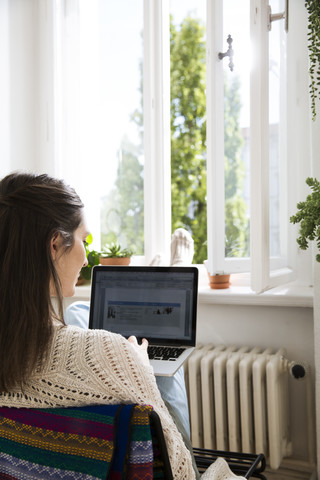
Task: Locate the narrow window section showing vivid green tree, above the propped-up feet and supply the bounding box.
[170,0,207,263]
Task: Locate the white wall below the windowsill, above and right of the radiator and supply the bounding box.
[197,303,315,460]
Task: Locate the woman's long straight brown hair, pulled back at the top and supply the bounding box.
[0,173,83,392]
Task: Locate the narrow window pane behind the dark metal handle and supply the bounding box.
[222,0,250,258]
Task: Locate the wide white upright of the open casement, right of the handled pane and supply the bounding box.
[250,0,270,292]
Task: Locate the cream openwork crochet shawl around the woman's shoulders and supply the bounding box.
[0,326,245,480]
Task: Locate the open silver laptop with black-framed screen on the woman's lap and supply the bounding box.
[89,265,198,376]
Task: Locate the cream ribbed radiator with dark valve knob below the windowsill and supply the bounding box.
[185,345,306,469]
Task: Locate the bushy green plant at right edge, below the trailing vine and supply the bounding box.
[290,177,320,262]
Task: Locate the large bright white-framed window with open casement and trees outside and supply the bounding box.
[52,0,308,292]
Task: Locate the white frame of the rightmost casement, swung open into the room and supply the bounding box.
[250,0,294,293]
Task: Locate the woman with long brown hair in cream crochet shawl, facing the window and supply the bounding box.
[0,173,245,480]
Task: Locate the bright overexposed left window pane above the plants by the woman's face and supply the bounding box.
[94,0,144,255]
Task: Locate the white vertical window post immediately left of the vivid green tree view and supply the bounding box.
[143,0,171,264]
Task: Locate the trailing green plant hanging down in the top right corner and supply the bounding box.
[305,0,320,120]
